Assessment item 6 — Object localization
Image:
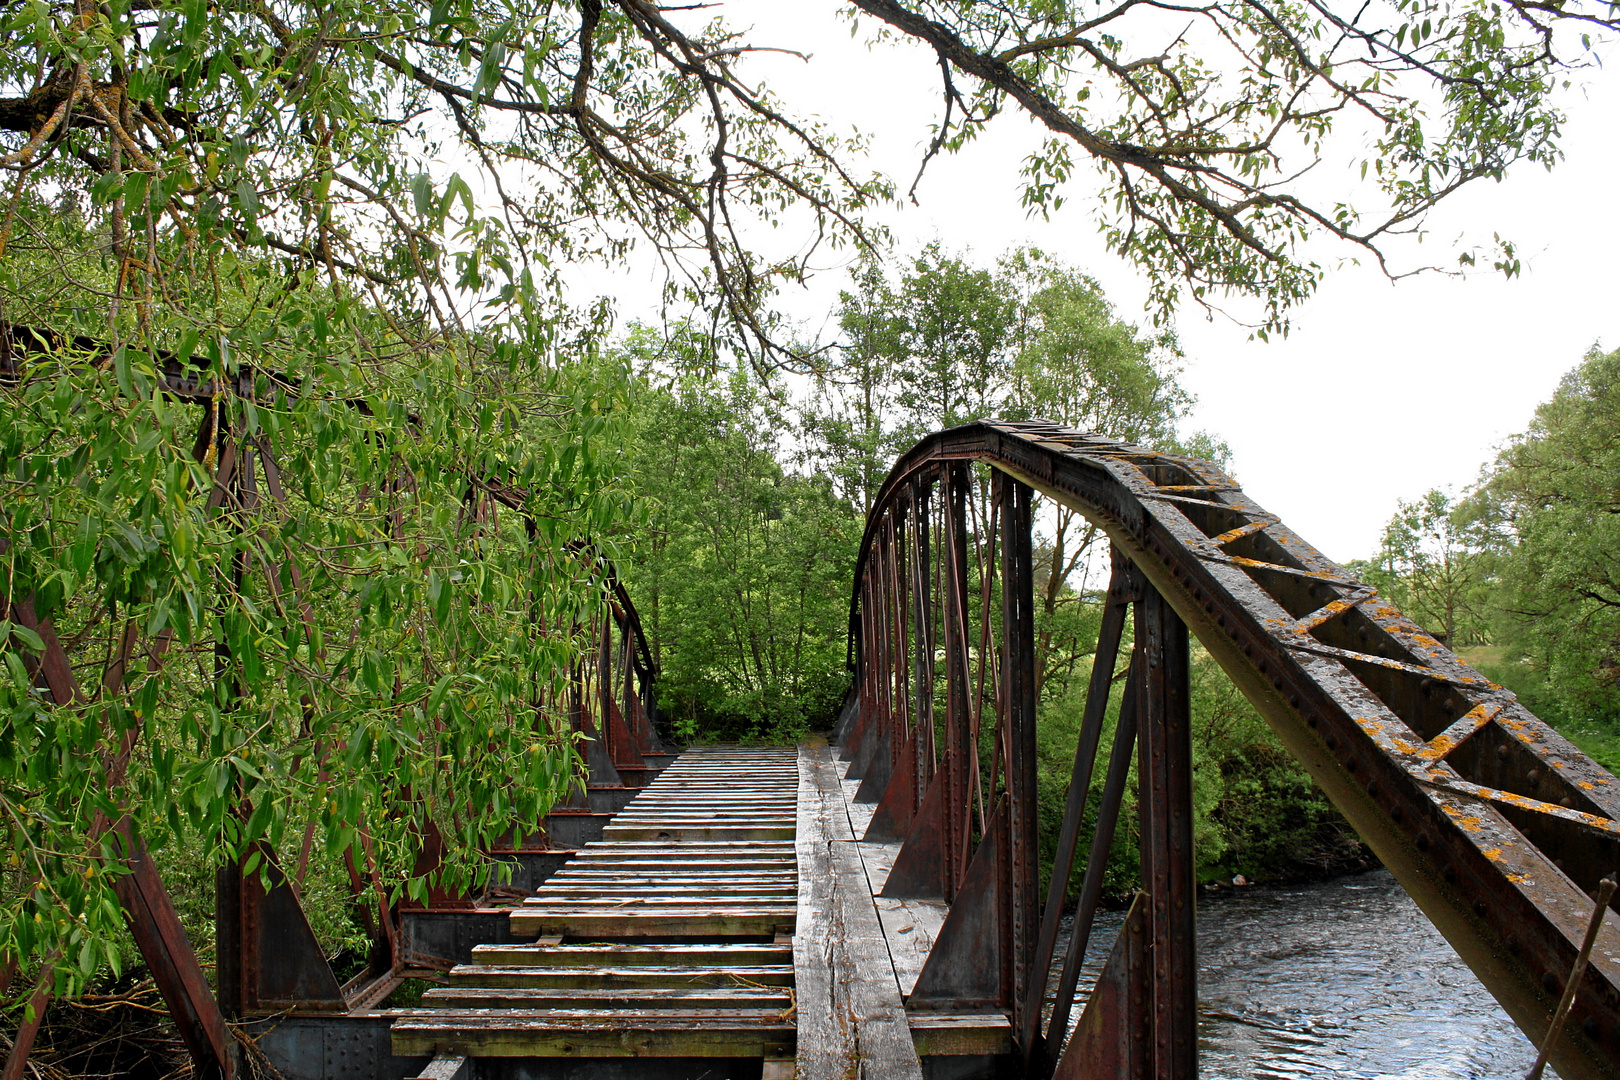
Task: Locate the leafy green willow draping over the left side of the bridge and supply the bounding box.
[0,0,876,1029]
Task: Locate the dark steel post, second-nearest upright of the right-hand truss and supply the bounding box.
[1000,476,1040,1031]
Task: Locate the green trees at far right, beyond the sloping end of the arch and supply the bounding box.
[1353,341,1620,771]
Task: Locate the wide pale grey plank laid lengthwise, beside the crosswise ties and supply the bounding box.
[794,743,922,1080]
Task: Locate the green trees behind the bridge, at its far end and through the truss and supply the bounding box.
[604,248,1367,895]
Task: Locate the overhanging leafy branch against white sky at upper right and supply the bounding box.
[852,0,1617,337]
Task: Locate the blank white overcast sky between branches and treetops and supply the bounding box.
[589,0,1620,562]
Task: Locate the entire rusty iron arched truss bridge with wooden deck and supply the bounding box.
[11,365,1620,1080]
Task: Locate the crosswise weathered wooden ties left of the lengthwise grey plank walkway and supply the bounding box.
[392,746,799,1075]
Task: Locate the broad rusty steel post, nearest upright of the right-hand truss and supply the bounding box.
[1136,583,1197,1080]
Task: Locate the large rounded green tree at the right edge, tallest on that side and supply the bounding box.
[1466,348,1620,725]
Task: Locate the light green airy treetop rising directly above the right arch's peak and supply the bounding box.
[807,244,1225,693]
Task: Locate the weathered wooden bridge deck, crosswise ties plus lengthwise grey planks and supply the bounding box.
[392,745,1009,1080]
